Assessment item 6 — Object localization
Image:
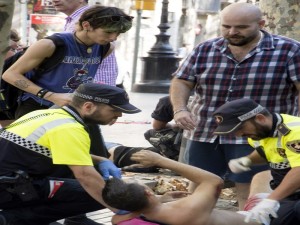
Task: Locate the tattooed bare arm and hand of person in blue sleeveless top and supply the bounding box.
[2,39,71,106]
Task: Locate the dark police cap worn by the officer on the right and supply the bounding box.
[213,98,265,134]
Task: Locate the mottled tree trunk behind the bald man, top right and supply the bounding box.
[259,0,300,41]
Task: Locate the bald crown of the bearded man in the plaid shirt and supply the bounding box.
[221,3,262,22]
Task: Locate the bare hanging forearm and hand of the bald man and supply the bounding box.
[170,77,196,130]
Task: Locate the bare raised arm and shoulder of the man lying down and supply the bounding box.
[131,150,223,225]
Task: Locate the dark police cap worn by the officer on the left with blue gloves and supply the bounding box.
[74,83,141,114]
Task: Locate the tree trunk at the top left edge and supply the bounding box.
[0,0,15,71]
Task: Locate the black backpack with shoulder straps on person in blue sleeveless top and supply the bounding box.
[0,35,110,120]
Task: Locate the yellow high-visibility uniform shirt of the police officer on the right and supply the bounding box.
[248,114,300,189]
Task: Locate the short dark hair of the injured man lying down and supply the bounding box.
[102,178,149,212]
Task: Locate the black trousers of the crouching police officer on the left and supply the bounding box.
[0,178,105,225]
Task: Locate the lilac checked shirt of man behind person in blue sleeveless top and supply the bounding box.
[64,5,118,86]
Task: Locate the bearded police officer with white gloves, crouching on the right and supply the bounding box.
[213,98,300,225]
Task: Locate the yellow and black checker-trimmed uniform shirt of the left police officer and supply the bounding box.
[0,106,93,177]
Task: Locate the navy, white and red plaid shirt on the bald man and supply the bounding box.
[174,31,300,144]
